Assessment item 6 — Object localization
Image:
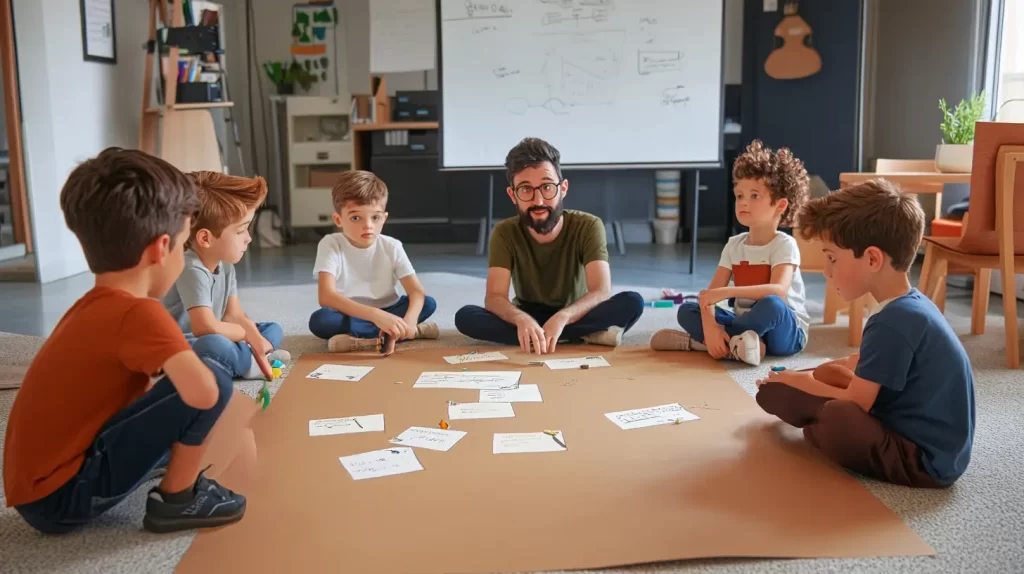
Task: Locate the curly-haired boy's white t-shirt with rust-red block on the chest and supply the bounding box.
[718,231,811,341]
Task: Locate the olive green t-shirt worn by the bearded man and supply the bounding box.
[488,210,608,309]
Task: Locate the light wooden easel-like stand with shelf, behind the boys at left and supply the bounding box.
[138,0,238,172]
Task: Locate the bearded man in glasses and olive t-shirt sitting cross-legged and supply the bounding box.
[455,138,643,354]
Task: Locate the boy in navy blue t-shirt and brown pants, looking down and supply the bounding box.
[757,180,975,487]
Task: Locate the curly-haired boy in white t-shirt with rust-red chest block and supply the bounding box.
[650,140,810,365]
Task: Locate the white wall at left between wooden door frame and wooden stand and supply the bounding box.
[12,0,147,282]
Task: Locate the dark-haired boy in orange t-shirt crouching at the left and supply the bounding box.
[3,148,256,533]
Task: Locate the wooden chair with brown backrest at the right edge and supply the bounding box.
[921,122,1024,368]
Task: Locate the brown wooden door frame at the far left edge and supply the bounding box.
[0,0,32,253]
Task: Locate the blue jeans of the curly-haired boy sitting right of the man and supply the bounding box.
[677,295,807,357]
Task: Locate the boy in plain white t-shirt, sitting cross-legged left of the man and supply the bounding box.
[309,171,438,353]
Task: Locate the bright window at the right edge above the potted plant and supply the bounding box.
[990,0,1024,123]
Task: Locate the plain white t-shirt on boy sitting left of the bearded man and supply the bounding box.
[313,233,416,309]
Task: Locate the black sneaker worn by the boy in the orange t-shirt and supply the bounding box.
[142,473,246,533]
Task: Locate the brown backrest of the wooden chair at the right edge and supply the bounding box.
[959,122,1024,255]
